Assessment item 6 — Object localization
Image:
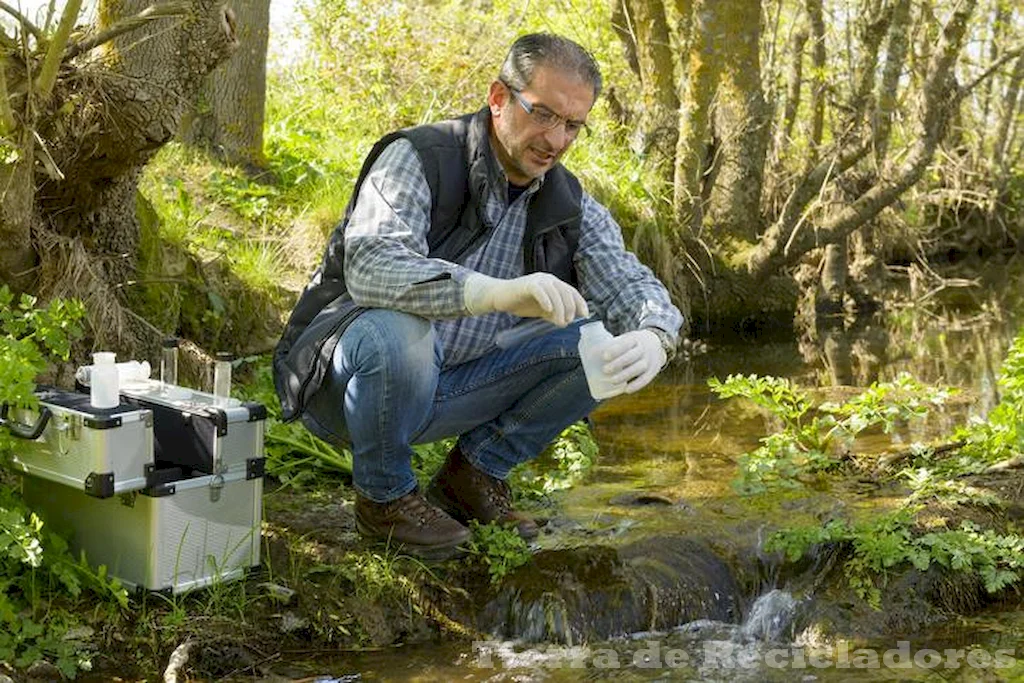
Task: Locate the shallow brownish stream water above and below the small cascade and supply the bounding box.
[270,286,1024,681]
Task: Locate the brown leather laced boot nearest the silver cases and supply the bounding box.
[355,490,470,560]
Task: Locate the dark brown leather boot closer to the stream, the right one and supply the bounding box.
[427,445,538,541]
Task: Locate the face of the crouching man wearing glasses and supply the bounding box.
[487,67,594,185]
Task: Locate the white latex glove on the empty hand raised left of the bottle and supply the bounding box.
[463,272,590,328]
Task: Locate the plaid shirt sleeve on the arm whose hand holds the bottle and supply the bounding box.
[575,193,683,342]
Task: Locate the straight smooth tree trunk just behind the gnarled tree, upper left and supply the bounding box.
[181,0,270,172]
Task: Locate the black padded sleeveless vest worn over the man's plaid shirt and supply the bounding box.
[273,109,583,422]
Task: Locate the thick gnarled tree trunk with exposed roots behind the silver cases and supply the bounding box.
[11,0,236,351]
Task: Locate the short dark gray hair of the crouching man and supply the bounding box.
[498,33,601,101]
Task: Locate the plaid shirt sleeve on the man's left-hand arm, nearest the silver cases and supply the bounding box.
[345,139,471,318]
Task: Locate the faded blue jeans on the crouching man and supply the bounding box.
[303,308,597,503]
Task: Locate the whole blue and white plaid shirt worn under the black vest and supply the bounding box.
[345,139,682,367]
